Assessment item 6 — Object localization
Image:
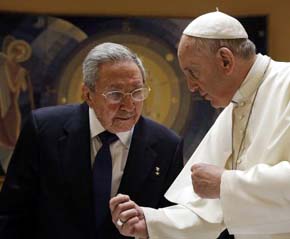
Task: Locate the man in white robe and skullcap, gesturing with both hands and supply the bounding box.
[110,12,290,239]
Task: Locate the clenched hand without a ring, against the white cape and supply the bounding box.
[191,163,224,198]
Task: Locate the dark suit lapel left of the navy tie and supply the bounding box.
[58,104,93,230]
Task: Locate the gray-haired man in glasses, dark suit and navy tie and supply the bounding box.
[0,43,183,239]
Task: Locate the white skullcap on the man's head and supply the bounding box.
[183,11,248,39]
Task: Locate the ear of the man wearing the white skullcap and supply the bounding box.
[216,47,235,75]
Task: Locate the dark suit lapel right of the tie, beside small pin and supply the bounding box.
[118,117,157,194]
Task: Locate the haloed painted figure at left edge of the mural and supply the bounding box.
[0,36,34,150]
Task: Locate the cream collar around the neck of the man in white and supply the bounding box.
[232,54,271,103]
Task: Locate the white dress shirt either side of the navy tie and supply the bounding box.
[89,108,134,197]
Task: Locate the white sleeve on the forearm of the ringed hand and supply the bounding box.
[142,205,225,239]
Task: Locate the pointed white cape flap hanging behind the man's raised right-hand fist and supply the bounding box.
[165,104,233,223]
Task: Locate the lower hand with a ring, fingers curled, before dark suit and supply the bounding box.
[110,194,148,239]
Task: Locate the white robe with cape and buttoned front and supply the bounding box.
[143,54,290,239]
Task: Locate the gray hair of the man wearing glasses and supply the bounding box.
[83,42,146,90]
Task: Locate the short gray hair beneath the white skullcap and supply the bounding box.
[193,37,256,59]
